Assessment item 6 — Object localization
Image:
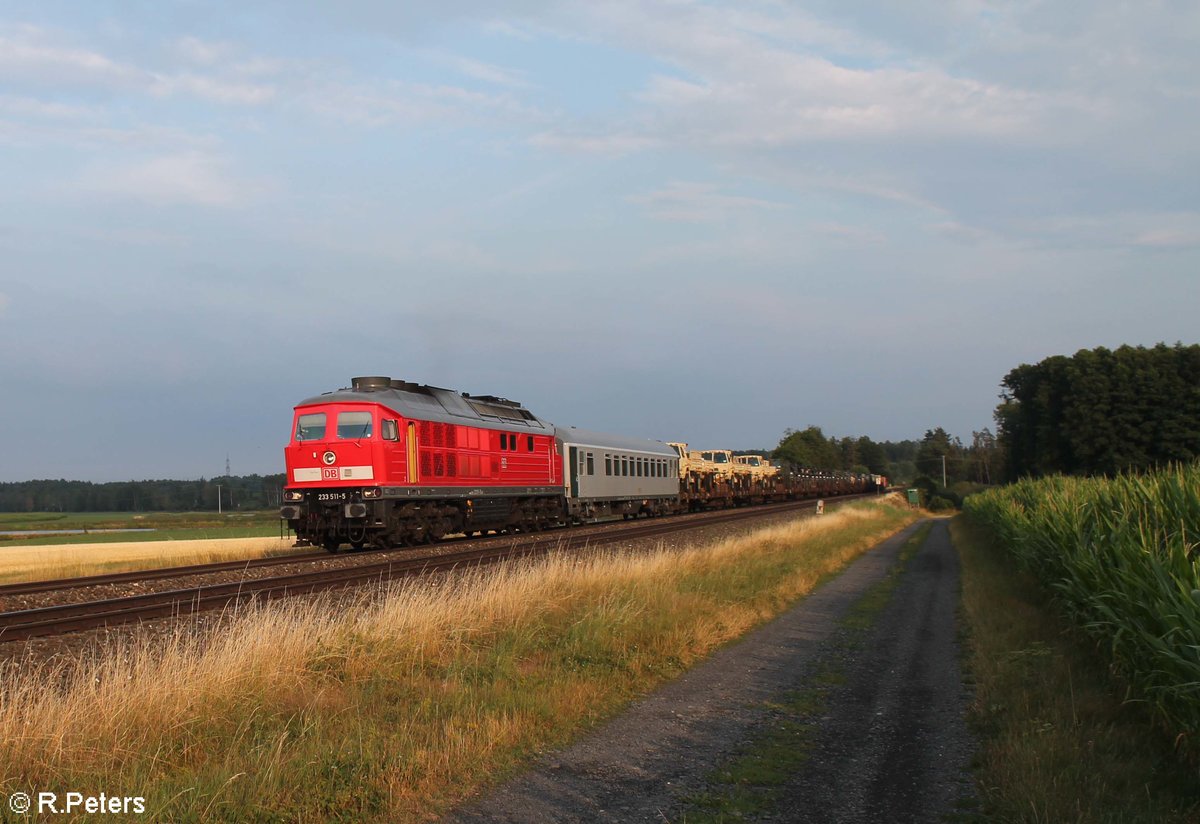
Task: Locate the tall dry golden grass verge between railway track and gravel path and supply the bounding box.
[0,504,916,822]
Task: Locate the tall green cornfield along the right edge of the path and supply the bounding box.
[964,464,1200,758]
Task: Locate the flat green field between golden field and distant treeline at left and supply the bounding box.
[0,510,286,546]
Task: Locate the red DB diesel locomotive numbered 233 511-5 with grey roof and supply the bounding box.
[281,377,563,551]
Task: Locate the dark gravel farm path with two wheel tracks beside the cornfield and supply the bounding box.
[448,522,972,823]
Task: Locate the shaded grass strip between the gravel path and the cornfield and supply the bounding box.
[950,517,1200,824]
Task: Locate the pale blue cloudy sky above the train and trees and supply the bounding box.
[0,0,1200,481]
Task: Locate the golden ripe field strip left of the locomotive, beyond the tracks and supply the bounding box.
[0,537,302,583]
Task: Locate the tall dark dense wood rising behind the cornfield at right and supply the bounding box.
[996,343,1200,480]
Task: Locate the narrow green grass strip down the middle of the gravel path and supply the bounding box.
[683,523,932,824]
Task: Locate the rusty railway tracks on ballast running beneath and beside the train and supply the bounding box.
[0,495,863,643]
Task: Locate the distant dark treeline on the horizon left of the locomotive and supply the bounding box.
[0,473,284,512]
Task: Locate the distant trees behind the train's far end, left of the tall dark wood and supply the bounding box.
[772,426,1004,485]
